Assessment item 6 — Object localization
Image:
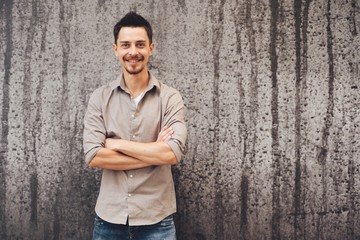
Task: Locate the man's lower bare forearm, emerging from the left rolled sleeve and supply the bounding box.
[89,148,151,170]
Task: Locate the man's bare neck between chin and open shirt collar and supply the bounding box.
[124,71,150,97]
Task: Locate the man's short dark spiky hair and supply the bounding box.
[114,11,152,44]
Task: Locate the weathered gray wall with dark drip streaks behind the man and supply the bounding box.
[0,0,360,240]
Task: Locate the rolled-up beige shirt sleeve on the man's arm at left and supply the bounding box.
[83,89,106,164]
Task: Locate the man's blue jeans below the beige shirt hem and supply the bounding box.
[93,215,176,240]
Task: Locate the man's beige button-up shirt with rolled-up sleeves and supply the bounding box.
[84,74,187,226]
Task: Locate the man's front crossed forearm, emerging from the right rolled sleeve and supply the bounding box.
[106,139,177,165]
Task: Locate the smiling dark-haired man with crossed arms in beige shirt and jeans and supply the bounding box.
[84,12,187,240]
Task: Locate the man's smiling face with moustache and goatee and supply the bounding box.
[113,27,154,75]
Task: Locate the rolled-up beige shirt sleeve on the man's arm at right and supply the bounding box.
[163,91,187,162]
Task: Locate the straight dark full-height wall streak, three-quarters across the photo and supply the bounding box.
[269,0,281,240]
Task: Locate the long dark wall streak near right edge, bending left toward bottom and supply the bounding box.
[317,0,335,236]
